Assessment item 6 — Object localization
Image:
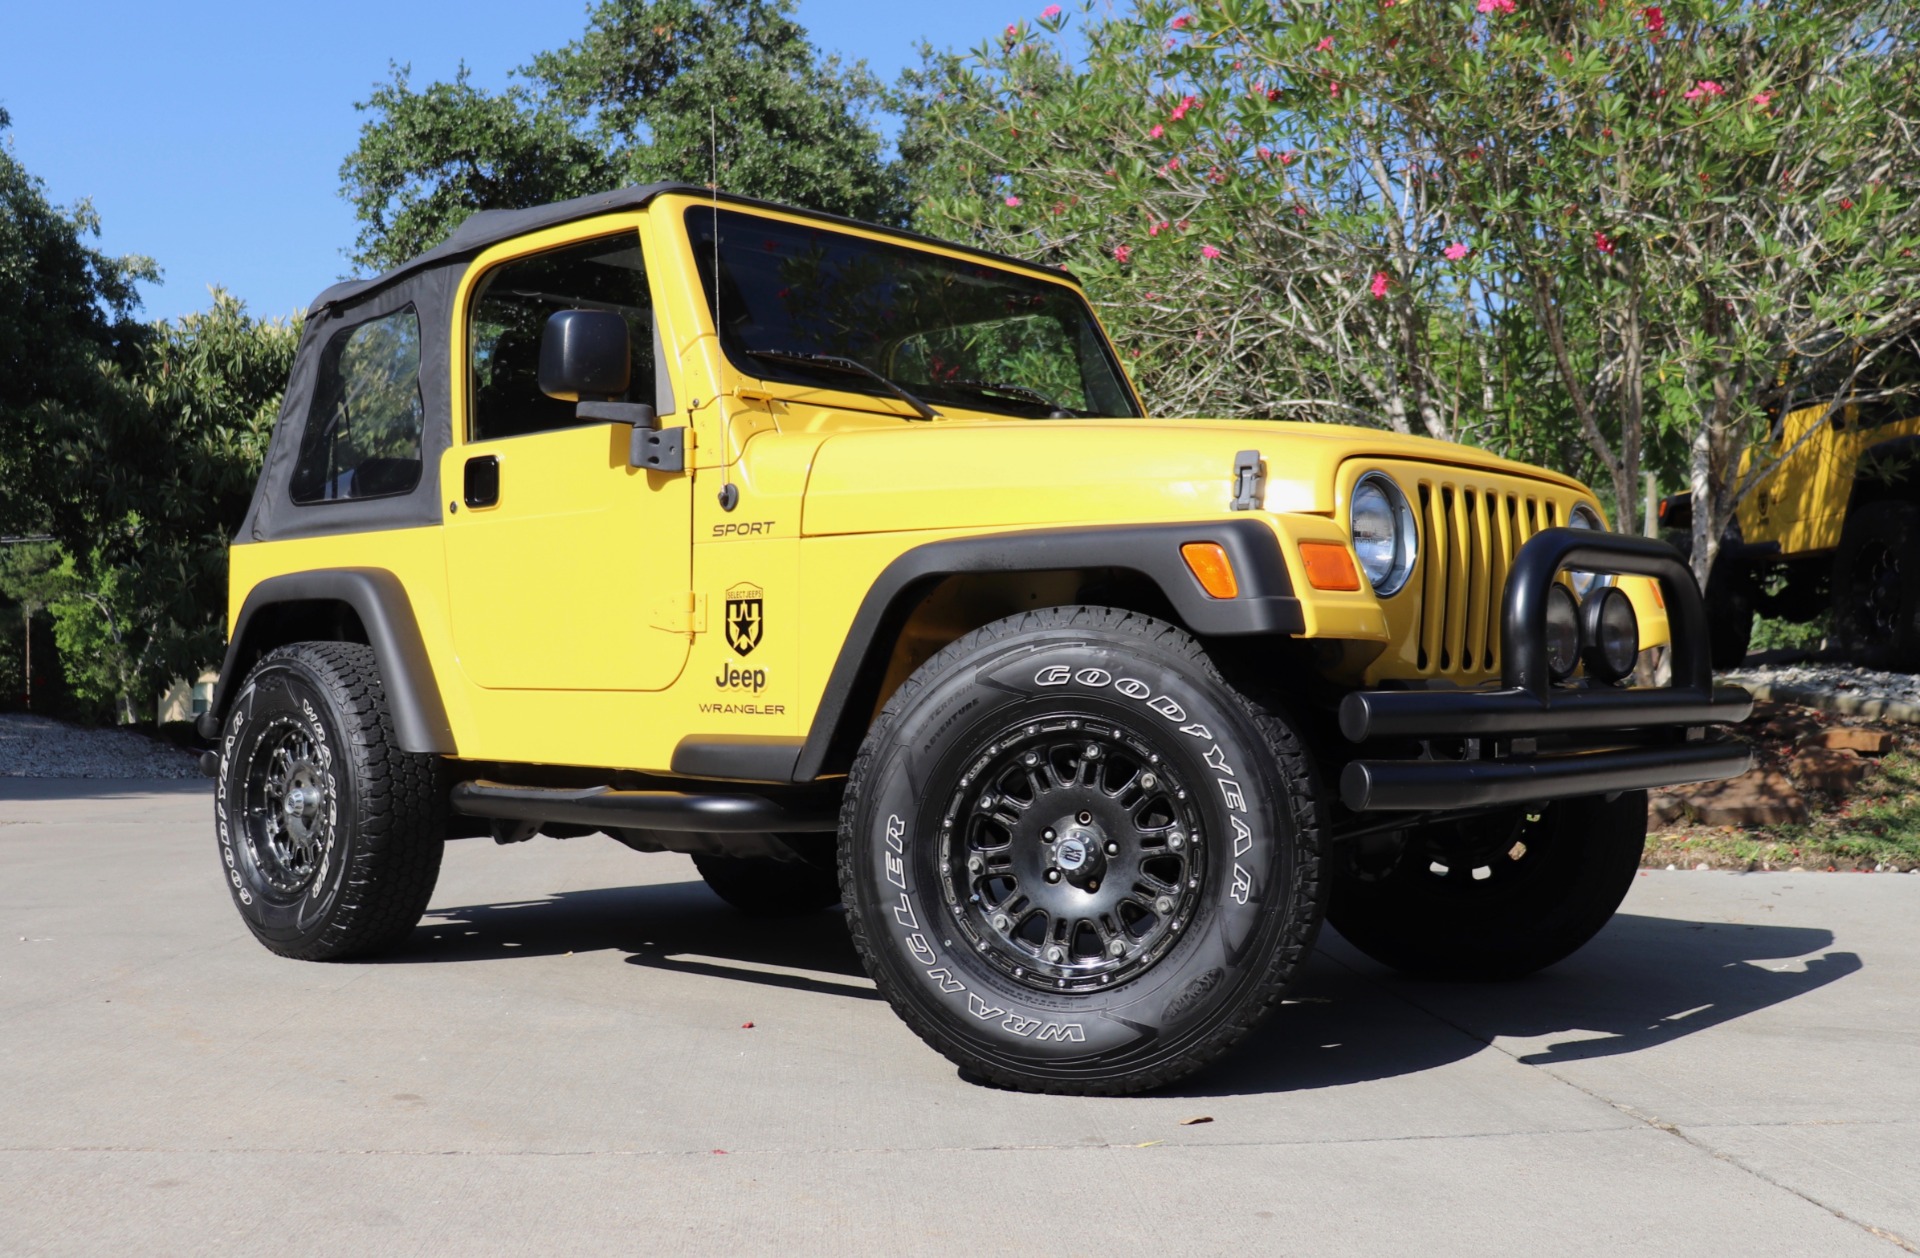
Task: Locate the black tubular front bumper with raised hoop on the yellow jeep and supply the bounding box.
[1340,528,1753,812]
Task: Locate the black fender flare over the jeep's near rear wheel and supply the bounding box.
[198,569,455,755]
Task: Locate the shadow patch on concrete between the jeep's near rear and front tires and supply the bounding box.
[405,882,879,1001]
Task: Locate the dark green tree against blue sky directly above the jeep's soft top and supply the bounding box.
[340,0,904,267]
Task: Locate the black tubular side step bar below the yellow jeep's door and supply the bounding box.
[451,782,839,834]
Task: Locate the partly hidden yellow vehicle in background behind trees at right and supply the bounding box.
[1659,357,1920,672]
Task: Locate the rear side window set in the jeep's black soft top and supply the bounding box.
[288,305,426,503]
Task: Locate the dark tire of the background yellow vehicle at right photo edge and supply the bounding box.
[1834,503,1920,672]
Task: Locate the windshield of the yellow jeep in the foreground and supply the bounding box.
[687,206,1140,419]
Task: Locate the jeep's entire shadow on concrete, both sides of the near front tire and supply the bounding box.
[397,882,1862,1097]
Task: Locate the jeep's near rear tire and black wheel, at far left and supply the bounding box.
[215,641,445,960]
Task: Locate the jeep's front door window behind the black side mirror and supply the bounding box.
[467,230,655,442]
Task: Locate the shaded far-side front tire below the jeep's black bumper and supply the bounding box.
[1327,791,1647,980]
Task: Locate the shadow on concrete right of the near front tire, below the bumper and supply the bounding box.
[1177,912,1862,1097]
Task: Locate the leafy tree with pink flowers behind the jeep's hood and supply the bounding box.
[900,0,1920,564]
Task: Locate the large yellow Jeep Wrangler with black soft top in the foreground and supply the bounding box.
[202,186,1751,1093]
